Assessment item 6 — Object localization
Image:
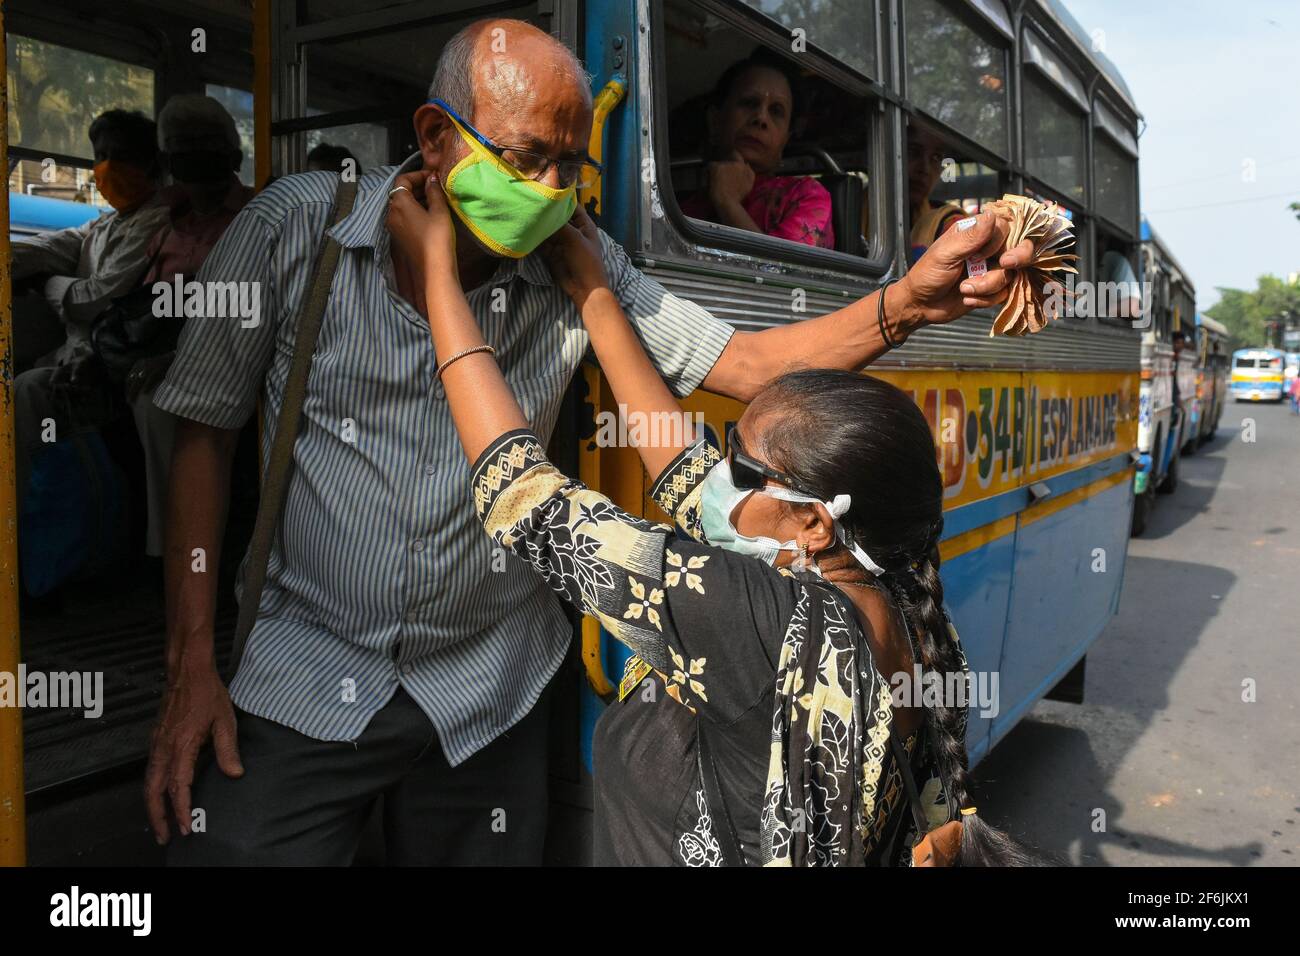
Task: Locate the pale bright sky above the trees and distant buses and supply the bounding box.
[1065,0,1300,310]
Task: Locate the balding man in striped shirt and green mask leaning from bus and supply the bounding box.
[146,20,1027,864]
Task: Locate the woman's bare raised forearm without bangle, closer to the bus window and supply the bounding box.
[543,207,702,477]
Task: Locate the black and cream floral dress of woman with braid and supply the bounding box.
[472,429,972,866]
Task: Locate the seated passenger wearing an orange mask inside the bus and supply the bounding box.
[12,109,168,522]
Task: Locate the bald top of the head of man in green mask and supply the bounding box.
[429,20,592,122]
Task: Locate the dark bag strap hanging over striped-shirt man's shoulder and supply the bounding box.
[230,177,356,675]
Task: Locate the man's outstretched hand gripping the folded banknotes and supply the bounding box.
[885,209,1034,334]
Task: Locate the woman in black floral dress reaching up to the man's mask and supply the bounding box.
[389,174,1027,866]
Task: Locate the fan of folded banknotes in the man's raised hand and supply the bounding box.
[984,194,1079,336]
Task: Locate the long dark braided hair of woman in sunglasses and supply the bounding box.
[751,369,1039,866]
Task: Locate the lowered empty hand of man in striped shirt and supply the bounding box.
[144,663,243,844]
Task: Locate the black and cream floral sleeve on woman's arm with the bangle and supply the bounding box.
[472,429,798,723]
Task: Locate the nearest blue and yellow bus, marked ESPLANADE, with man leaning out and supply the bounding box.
[0,0,1144,861]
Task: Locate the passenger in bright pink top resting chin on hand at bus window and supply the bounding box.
[681,47,835,248]
